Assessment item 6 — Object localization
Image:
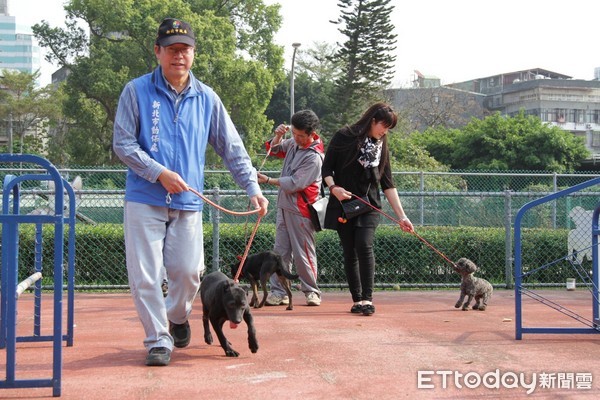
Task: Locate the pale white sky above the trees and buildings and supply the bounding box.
[9,0,600,87]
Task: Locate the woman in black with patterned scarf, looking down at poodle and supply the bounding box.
[322,103,413,315]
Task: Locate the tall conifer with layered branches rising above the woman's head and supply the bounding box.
[332,0,396,123]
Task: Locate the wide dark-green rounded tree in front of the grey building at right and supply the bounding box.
[411,111,589,173]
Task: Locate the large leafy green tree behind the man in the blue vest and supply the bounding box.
[33,0,283,164]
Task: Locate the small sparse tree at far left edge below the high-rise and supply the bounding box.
[0,69,61,153]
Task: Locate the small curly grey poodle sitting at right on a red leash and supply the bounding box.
[454,257,494,311]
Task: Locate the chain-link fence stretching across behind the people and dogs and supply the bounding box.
[0,168,598,289]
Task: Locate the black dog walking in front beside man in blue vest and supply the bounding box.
[200,271,258,357]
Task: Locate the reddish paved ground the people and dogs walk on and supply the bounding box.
[0,290,600,400]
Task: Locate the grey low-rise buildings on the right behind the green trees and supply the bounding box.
[386,68,600,165]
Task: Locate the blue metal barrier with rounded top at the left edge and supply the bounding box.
[0,154,75,397]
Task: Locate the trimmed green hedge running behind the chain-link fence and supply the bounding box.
[5,223,573,287]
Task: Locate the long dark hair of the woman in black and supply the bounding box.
[338,103,398,175]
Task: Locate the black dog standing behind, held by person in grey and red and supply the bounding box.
[231,251,298,310]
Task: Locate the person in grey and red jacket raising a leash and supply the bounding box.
[258,110,324,306]
